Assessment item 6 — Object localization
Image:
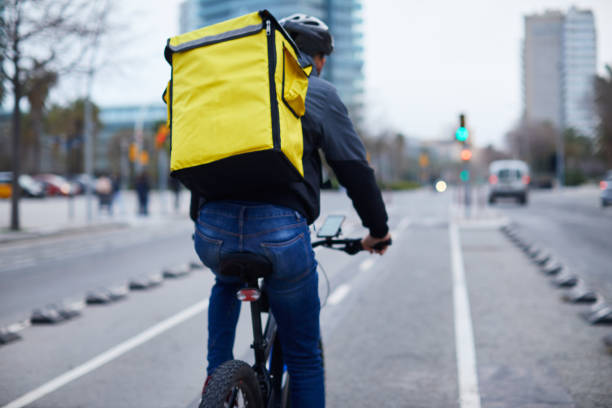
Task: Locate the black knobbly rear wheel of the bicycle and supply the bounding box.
[199,360,264,408]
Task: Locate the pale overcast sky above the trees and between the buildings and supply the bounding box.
[55,0,612,150]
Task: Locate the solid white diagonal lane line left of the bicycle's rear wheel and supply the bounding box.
[2,299,208,408]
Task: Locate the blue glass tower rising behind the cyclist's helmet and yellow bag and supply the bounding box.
[180,0,364,121]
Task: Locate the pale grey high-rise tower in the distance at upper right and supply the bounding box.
[523,7,597,136]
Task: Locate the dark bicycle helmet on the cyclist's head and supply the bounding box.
[279,13,334,56]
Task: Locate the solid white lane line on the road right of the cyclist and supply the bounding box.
[449,223,480,408]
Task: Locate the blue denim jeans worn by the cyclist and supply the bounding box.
[195,201,325,408]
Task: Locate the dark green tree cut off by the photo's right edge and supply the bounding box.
[595,65,612,168]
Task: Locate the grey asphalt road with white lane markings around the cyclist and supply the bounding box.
[0,190,612,408]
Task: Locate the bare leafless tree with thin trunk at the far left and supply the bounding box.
[0,0,112,230]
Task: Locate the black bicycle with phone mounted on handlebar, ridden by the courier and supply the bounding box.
[199,215,391,408]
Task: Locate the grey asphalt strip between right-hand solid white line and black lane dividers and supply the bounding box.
[460,223,612,408]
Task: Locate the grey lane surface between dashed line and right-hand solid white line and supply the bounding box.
[323,222,458,407]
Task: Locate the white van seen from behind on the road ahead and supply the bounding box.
[489,160,530,205]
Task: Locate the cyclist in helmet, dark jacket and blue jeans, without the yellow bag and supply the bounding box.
[191,14,390,408]
